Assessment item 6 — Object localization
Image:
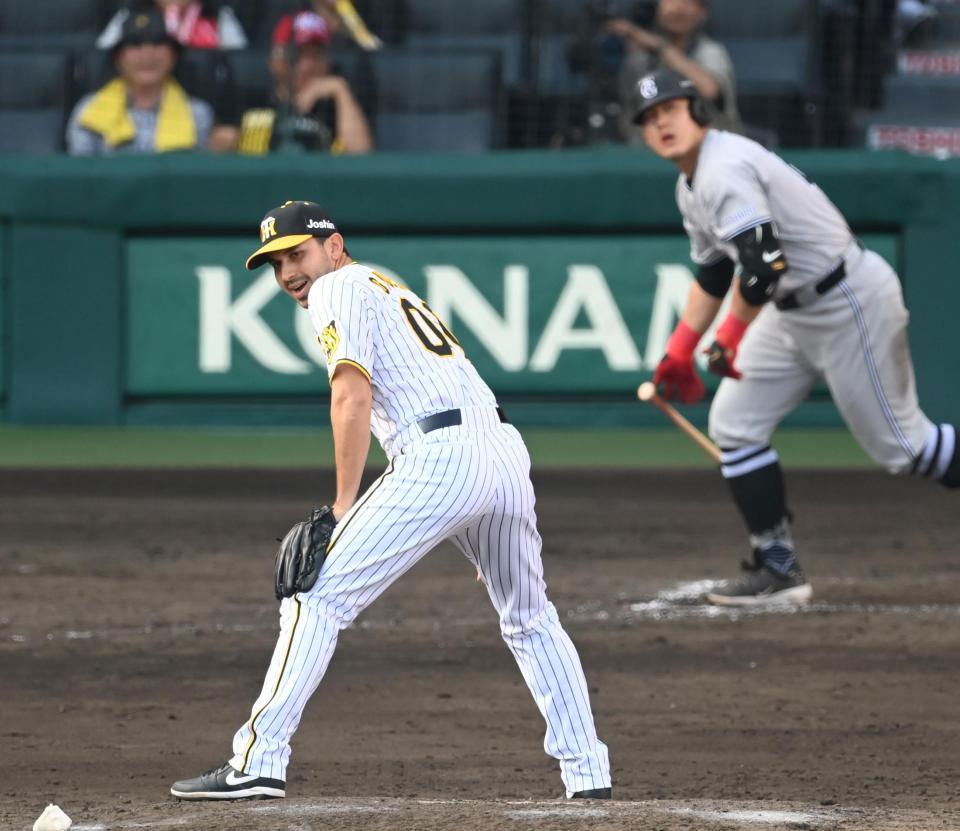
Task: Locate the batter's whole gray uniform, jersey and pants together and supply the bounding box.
[677,130,955,478]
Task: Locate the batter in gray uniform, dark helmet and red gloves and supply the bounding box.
[635,71,960,605]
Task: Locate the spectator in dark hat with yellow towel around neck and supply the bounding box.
[67,11,213,156]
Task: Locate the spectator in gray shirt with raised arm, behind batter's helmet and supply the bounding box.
[607,0,743,144]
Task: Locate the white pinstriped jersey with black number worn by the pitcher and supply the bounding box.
[308,263,496,456]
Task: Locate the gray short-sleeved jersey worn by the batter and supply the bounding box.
[676,130,853,297]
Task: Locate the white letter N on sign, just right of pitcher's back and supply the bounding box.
[423,265,530,372]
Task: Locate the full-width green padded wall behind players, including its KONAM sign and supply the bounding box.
[0,148,960,425]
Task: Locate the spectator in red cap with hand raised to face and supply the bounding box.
[229,11,373,155]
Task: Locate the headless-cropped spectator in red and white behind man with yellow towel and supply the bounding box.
[97,0,247,49]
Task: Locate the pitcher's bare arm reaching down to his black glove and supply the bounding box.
[330,363,373,519]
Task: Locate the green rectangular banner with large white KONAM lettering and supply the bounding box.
[125,234,896,397]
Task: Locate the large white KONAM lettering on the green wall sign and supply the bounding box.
[195,263,704,375]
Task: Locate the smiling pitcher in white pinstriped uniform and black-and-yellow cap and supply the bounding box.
[171,202,611,799]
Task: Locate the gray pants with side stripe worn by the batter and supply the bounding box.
[710,245,936,473]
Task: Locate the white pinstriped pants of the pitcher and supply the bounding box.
[230,416,610,796]
